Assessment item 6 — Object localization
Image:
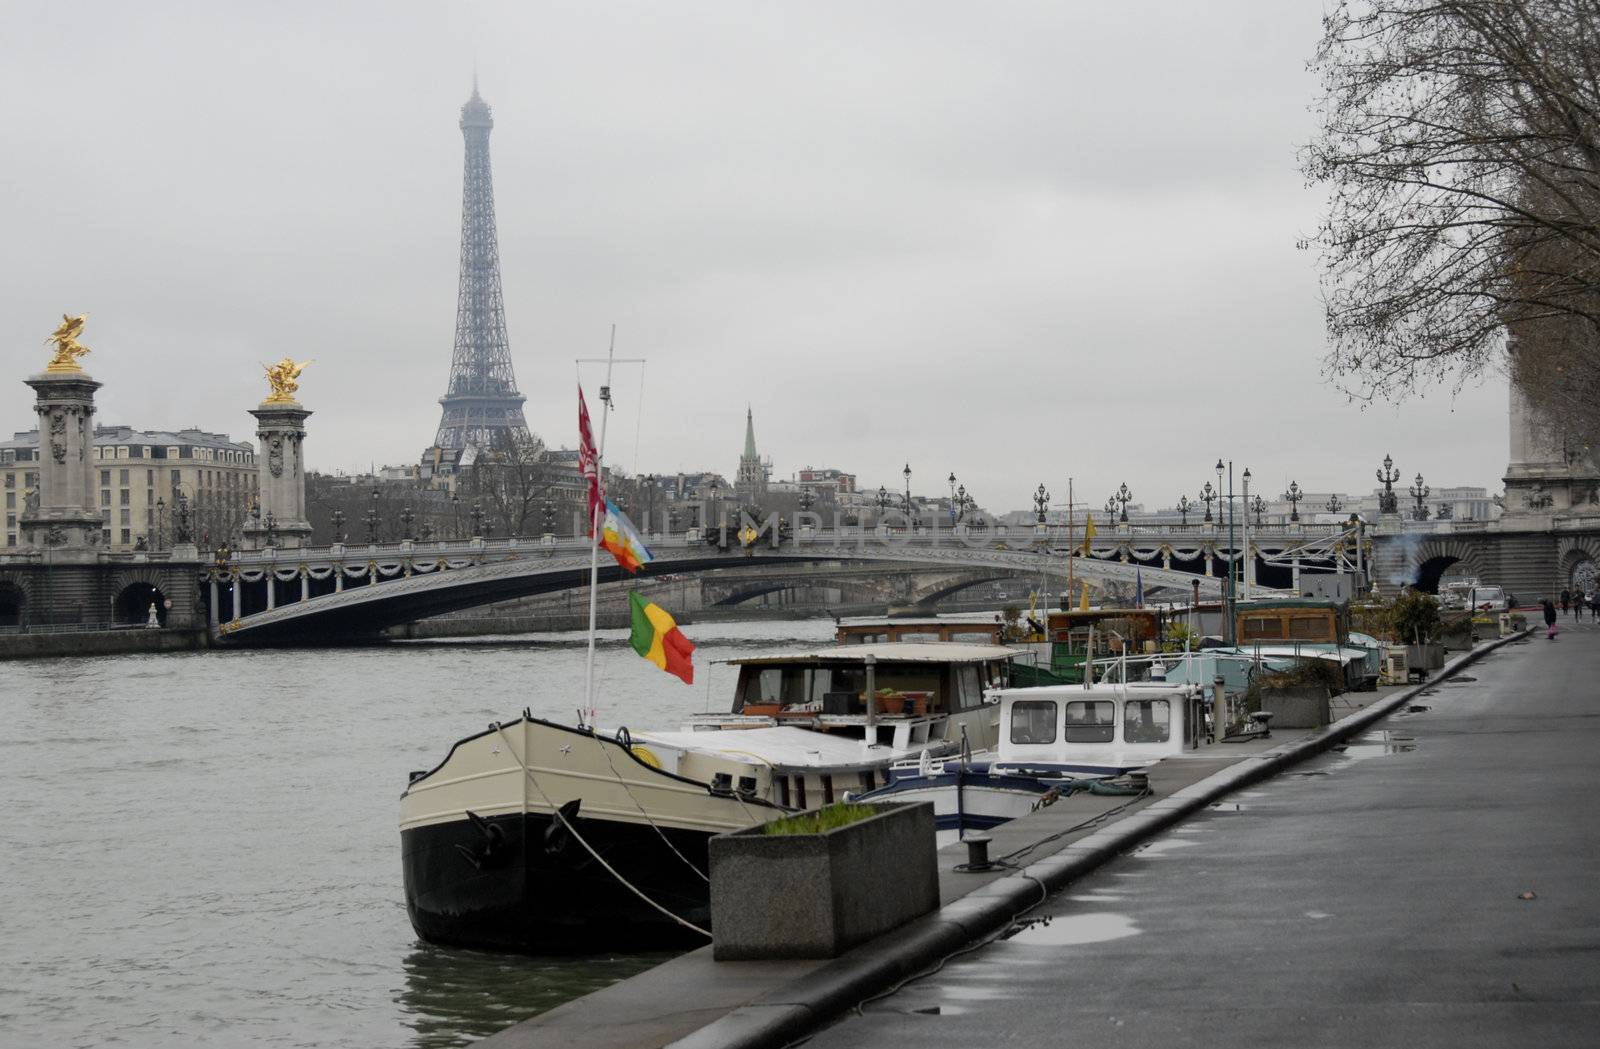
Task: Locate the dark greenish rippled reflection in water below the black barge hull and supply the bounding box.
[398,945,672,1049]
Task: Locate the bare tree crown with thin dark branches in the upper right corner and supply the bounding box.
[1302,0,1600,402]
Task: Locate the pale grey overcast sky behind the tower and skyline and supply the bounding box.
[0,0,1507,510]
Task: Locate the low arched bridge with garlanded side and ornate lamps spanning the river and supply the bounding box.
[202,529,1324,641]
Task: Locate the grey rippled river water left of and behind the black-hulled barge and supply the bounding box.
[0,620,832,1049]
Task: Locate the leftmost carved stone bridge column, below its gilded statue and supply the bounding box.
[21,365,102,560]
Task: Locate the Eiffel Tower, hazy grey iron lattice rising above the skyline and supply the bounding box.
[430,77,531,462]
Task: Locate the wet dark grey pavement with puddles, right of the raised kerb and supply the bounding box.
[806,620,1600,1049]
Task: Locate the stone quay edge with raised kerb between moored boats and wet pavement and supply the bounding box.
[480,646,1510,1049]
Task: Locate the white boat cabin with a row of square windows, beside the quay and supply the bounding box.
[994,683,1206,777]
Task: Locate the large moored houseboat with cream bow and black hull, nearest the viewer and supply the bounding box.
[400,643,1014,953]
